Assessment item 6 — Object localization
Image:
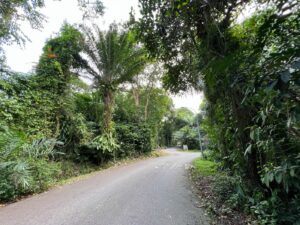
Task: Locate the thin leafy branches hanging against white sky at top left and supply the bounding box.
[0,0,104,75]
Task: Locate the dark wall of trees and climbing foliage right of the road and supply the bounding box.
[136,0,300,224]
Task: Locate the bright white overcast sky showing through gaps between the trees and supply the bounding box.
[4,0,203,112]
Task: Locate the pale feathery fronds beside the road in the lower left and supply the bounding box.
[0,126,60,201]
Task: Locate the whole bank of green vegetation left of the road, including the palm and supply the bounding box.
[0,1,173,201]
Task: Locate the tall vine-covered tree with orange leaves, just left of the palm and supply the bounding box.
[35,24,85,136]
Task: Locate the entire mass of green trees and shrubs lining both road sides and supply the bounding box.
[0,0,300,224]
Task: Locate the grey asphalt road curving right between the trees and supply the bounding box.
[0,149,208,225]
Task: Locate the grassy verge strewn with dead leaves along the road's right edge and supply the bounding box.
[190,158,255,225]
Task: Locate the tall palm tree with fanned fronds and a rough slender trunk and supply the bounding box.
[79,24,145,133]
